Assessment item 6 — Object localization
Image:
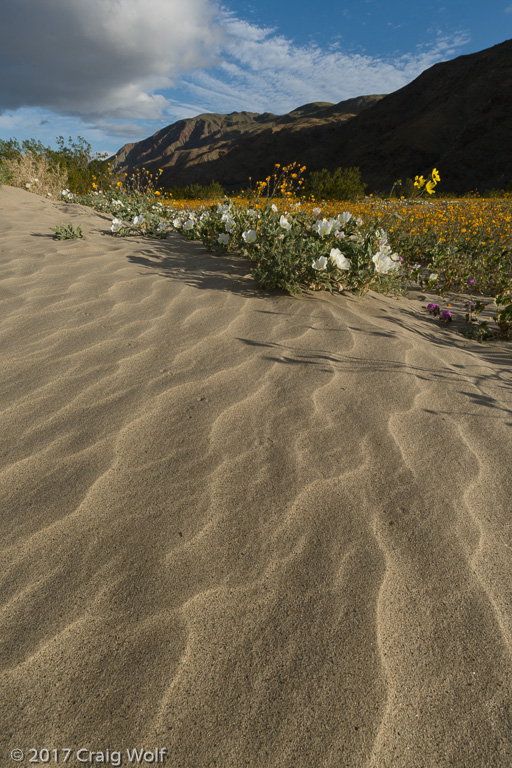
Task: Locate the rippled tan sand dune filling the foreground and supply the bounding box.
[0,187,512,768]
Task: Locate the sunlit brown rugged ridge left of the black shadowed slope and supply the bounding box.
[109,96,382,190]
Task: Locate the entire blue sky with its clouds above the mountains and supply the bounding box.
[0,0,512,154]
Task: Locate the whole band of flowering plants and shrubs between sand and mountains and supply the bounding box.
[0,137,512,340]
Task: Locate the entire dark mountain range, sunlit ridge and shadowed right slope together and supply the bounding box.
[110,40,512,193]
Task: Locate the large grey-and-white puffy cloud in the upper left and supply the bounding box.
[0,0,222,119]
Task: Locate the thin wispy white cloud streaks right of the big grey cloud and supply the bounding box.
[176,13,469,113]
